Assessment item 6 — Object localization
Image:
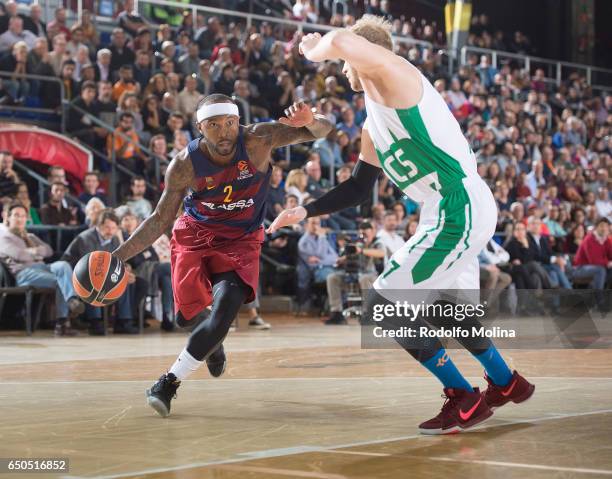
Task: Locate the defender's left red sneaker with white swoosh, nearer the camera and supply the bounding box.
[419,388,493,434]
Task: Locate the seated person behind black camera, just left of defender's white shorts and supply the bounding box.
[326,222,385,325]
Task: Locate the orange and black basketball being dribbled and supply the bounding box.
[72,251,128,306]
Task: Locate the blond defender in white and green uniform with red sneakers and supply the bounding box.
[268,15,534,434]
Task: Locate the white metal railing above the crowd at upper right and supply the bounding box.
[460,46,612,91]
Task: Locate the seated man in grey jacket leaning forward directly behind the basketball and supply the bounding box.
[62,208,138,336]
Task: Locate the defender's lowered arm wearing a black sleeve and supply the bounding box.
[266,129,381,233]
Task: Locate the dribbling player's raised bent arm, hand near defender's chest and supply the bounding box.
[249,101,333,149]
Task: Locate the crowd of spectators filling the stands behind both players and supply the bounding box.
[0,0,612,332]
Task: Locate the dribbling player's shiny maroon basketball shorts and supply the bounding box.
[170,215,264,320]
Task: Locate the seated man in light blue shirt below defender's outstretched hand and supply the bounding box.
[297,217,338,307]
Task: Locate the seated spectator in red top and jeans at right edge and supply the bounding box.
[572,218,612,290]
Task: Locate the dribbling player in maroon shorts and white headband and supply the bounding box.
[113,94,332,417]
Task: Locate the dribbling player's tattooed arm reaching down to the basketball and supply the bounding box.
[113,151,193,261]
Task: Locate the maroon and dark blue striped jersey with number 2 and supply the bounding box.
[183,130,272,239]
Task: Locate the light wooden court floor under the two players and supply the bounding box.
[0,315,612,479]
